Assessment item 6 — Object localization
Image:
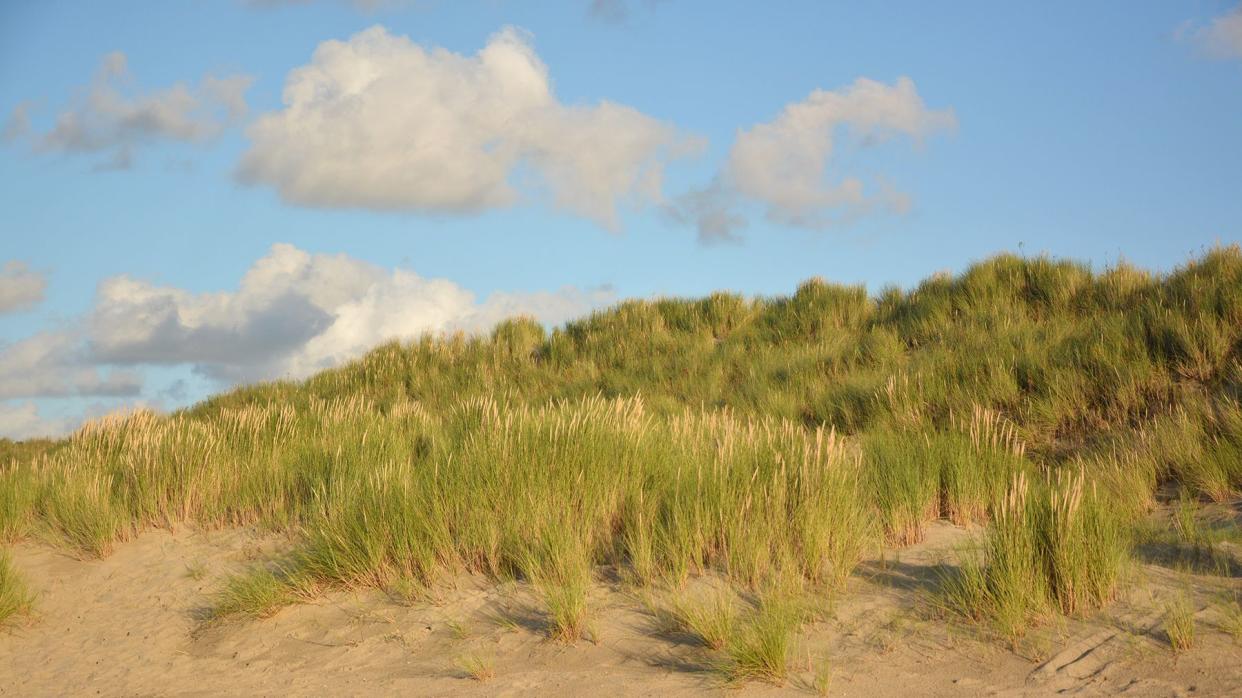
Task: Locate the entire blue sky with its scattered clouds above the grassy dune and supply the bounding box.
[0,0,1242,437]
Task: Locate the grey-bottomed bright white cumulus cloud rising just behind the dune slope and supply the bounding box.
[91,245,612,383]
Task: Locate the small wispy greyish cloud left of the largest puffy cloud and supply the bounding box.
[21,51,252,169]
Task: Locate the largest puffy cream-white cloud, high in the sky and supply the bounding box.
[238,26,697,230]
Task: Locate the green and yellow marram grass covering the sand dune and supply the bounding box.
[0,246,1242,660]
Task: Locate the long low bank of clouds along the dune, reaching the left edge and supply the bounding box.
[0,243,616,437]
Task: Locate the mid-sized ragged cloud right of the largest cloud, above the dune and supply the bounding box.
[667,77,956,240]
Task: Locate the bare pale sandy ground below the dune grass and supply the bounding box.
[0,524,1242,698]
